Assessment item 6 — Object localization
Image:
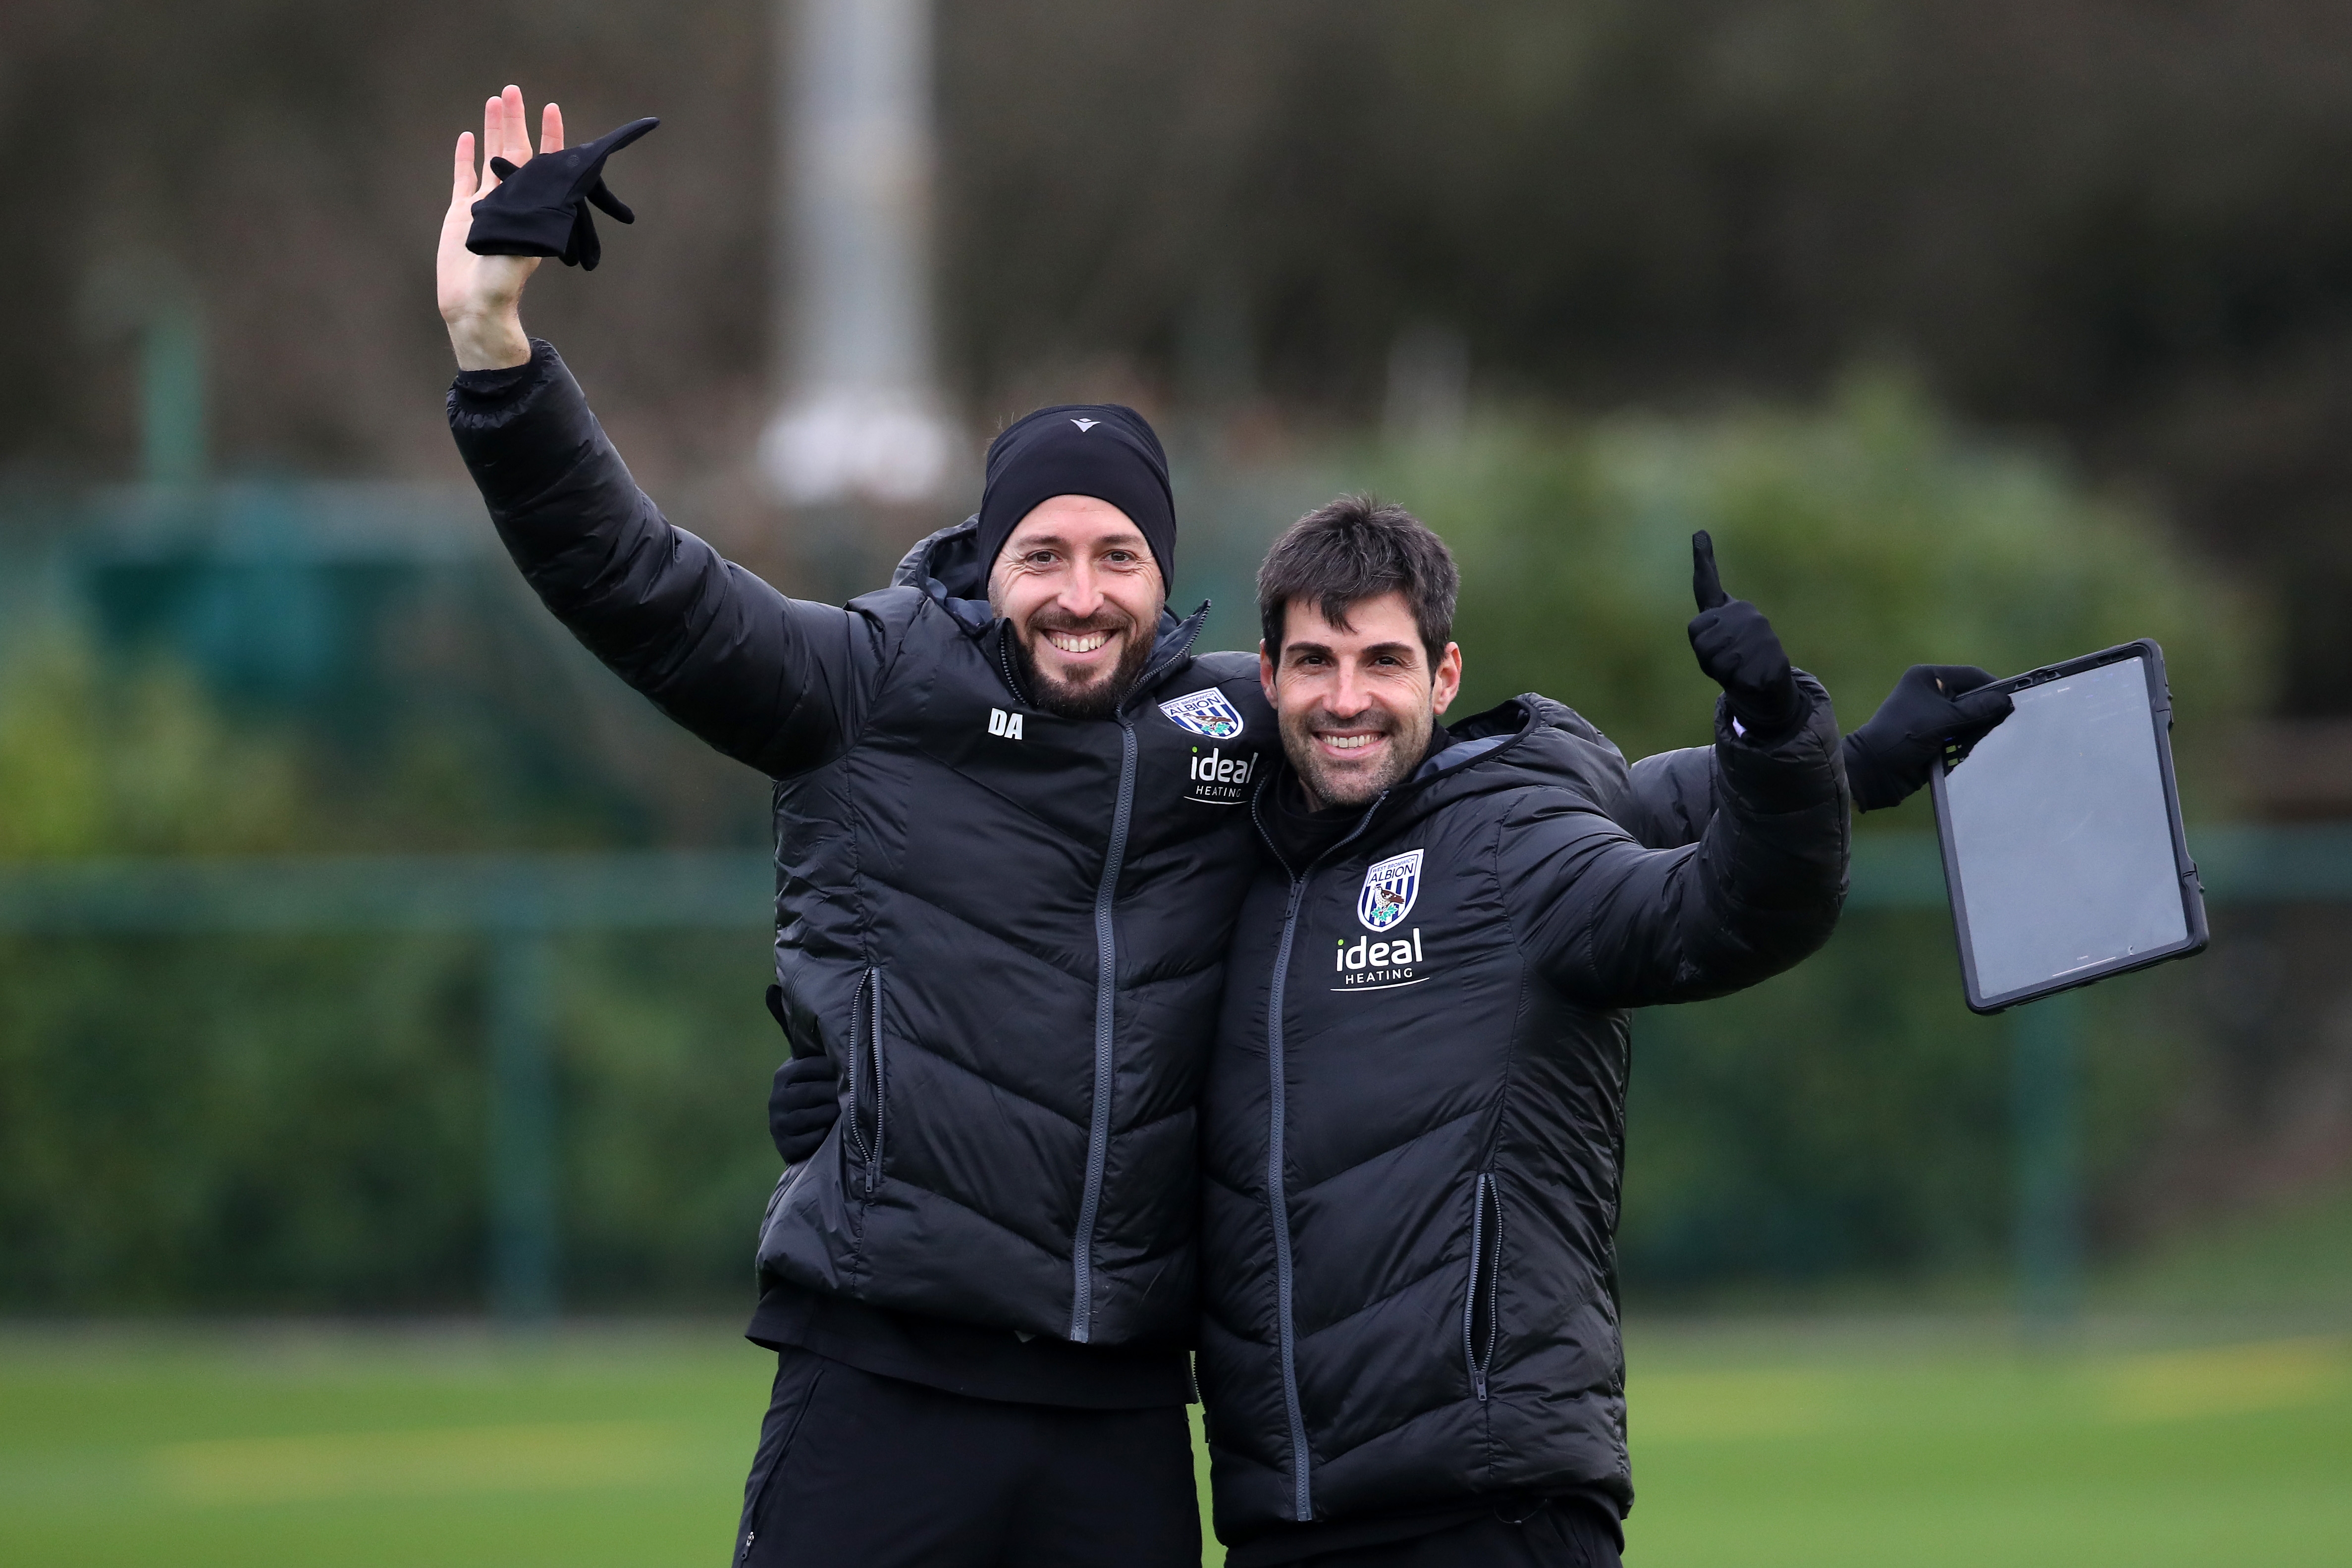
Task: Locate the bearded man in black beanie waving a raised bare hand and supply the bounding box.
[437,87,1275,1568]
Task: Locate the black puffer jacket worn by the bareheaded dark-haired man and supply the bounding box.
[1199,679,1846,1545]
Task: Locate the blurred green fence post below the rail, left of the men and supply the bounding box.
[489,926,555,1323]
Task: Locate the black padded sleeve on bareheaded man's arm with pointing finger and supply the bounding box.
[1498,677,1849,1008]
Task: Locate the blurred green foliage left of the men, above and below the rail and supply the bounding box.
[0,627,779,1312]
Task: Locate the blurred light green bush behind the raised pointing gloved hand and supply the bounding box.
[1369,371,2267,804]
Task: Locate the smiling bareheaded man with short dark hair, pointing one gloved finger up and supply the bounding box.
[1199,496,1846,1568]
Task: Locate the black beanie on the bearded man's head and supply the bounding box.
[978,402,1176,588]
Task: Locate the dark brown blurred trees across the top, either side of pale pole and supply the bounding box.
[0,0,2352,712]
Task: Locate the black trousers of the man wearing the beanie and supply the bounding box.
[734,1350,1199,1568]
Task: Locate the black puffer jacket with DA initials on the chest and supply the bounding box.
[452,343,1275,1347]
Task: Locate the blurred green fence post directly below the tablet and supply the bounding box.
[2009,992,2082,1331]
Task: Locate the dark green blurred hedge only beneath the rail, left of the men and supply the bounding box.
[0,929,781,1312]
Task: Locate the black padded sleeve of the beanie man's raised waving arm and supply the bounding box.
[449,339,884,778]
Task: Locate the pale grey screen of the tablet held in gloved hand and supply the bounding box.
[1945,658,2188,997]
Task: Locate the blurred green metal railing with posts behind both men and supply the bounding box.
[0,825,2352,1323]
